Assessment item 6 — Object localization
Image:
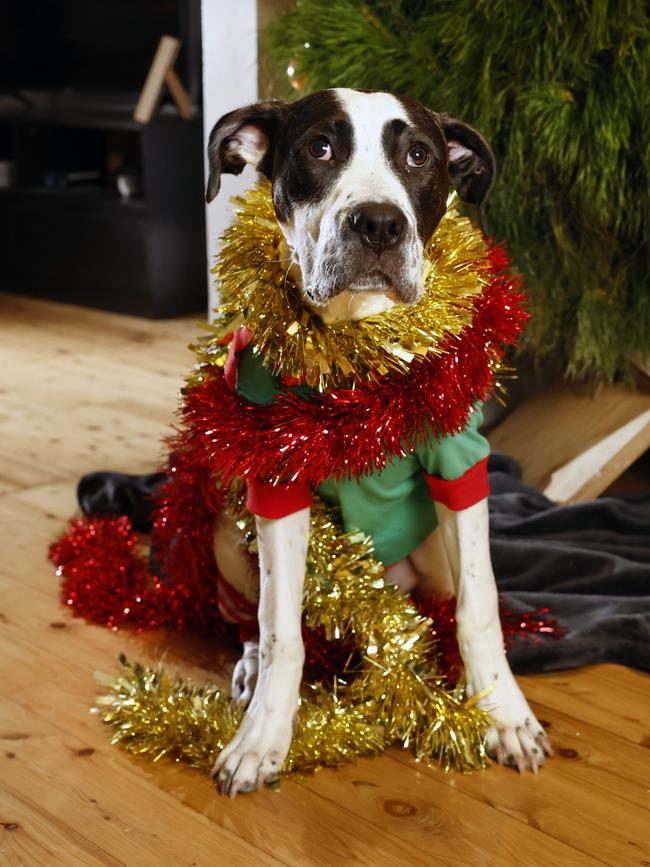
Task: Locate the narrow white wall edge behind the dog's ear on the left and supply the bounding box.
[201,0,257,308]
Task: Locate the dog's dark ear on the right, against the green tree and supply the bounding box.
[438,114,496,220]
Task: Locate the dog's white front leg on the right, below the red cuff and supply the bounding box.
[436,500,551,773]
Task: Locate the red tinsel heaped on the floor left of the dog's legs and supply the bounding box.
[50,443,224,633]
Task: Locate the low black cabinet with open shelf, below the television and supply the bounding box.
[0,107,207,318]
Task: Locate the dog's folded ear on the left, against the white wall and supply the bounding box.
[205,99,289,202]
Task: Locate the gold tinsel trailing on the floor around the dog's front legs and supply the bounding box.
[97,501,490,774]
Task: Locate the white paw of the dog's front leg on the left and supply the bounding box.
[211,708,292,798]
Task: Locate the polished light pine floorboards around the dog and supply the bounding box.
[0,295,650,867]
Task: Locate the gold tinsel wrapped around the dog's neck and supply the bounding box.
[190,182,490,391]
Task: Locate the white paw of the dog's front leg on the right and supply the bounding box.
[479,678,553,774]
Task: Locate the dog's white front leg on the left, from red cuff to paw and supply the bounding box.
[212,509,309,797]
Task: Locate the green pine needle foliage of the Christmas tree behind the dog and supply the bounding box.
[267,0,650,380]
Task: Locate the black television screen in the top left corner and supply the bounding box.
[0,0,183,92]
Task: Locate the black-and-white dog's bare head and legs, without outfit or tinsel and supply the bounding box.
[207,89,550,796]
